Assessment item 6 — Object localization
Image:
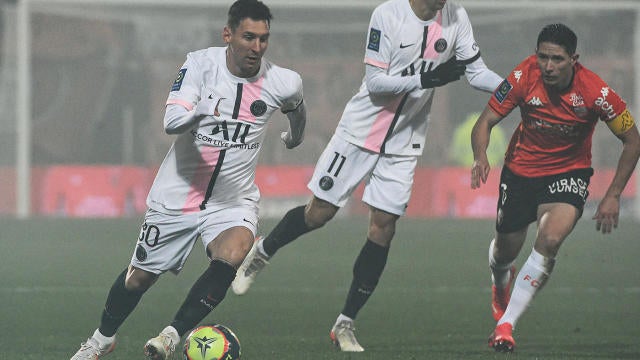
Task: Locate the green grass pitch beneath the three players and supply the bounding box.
[0,214,640,360]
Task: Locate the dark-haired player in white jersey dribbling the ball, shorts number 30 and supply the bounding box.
[71,0,306,360]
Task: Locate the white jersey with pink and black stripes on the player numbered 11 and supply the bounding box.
[336,0,480,155]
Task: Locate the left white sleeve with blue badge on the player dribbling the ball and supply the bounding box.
[167,53,203,111]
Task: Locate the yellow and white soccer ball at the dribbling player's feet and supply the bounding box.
[183,324,240,360]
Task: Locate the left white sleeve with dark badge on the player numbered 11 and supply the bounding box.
[364,7,393,70]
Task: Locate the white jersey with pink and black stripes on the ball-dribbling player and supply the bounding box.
[147,47,302,214]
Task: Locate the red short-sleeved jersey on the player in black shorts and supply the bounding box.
[489,55,627,177]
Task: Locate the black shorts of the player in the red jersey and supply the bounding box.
[496,166,593,233]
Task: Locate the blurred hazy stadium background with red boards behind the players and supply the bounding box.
[0,0,640,218]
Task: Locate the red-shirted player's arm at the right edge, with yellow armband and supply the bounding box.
[593,110,640,234]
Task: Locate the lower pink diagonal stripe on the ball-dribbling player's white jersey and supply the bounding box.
[182,146,222,213]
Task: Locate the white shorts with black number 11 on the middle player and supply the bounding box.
[307,135,418,216]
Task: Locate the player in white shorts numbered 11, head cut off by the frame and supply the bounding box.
[232,0,502,352]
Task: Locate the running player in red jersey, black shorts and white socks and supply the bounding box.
[471,24,640,352]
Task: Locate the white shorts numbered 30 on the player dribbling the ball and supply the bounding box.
[131,204,258,274]
